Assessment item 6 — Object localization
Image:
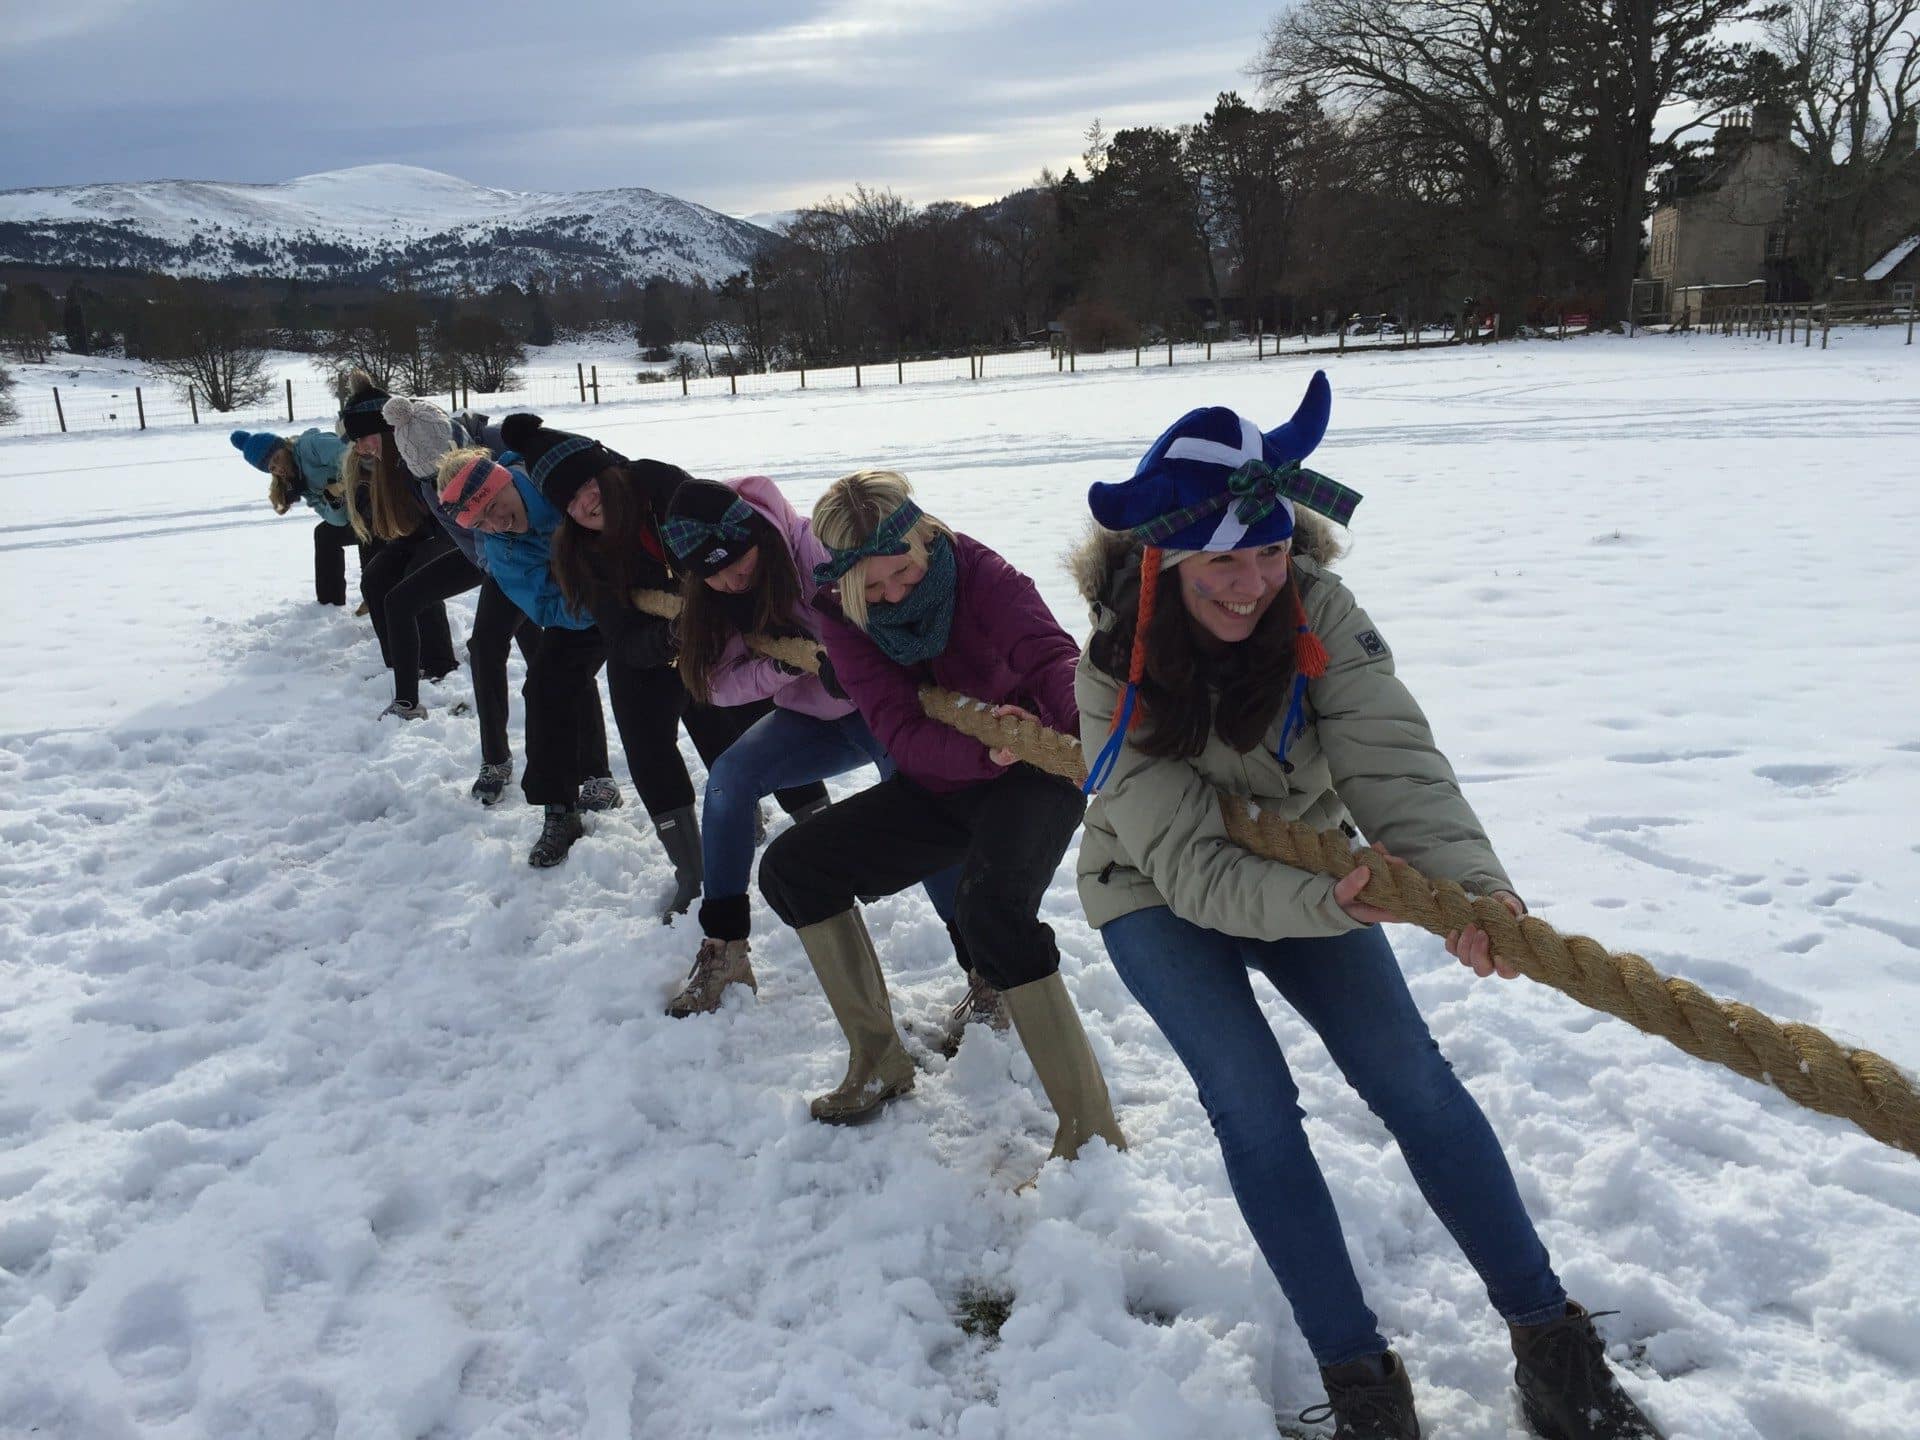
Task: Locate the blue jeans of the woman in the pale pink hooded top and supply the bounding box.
[701,708,960,920]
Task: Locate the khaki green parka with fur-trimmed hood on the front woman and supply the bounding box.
[1073,515,1513,941]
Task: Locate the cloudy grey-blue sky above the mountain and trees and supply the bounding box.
[0,0,1283,213]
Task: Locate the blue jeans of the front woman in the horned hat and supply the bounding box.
[1100,906,1567,1365]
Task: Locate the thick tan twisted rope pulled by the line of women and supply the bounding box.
[634,589,1920,1156]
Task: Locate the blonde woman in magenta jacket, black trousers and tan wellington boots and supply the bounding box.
[760,470,1123,1182]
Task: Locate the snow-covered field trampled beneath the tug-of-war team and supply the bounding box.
[0,334,1920,1440]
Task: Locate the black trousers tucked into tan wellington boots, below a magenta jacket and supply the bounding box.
[760,764,1087,991]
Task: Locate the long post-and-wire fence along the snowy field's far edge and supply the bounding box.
[0,321,1498,436]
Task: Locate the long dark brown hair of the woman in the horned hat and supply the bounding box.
[1110,557,1306,758]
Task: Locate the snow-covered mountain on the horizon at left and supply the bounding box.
[0,165,772,288]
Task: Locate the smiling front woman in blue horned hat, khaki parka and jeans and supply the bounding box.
[1075,374,1659,1440]
